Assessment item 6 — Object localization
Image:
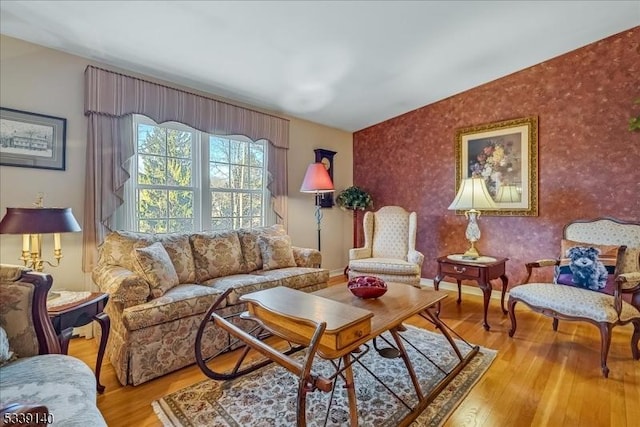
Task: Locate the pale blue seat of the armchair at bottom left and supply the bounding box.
[0,354,107,427]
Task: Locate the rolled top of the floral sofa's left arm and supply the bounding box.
[92,265,151,308]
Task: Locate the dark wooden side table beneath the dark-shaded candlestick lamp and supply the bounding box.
[47,291,111,393]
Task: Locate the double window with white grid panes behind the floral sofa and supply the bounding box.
[123,116,268,233]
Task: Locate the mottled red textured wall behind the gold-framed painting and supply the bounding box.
[354,27,640,284]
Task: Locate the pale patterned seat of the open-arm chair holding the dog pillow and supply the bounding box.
[509,283,640,323]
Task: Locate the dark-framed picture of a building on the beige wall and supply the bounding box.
[0,108,67,170]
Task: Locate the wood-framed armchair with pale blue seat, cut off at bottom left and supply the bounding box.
[0,264,107,427]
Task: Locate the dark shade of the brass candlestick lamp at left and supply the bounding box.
[0,208,81,234]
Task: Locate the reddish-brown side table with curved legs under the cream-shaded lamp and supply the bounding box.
[433,255,509,331]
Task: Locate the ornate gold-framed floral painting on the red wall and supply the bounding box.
[454,116,538,216]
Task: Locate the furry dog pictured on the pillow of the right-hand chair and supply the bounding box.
[567,246,608,291]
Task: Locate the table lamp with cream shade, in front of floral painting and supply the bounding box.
[449,178,498,259]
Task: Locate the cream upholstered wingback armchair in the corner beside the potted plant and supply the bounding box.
[348,206,424,287]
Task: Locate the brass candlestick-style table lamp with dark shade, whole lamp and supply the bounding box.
[0,197,81,271]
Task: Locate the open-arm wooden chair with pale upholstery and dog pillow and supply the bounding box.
[509,218,640,377]
